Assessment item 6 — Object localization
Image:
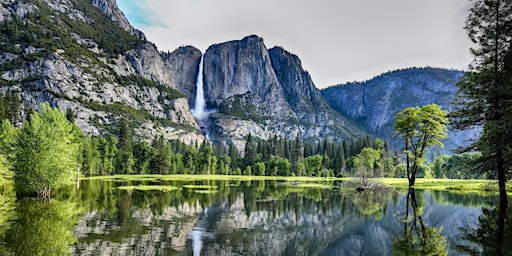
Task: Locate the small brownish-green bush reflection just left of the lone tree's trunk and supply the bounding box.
[353,190,391,219]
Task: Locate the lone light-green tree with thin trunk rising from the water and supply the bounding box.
[394,104,448,187]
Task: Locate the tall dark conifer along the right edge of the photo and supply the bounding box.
[452,0,512,224]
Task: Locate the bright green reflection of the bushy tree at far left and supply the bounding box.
[6,199,79,255]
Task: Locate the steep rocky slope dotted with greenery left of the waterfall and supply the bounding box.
[0,0,204,143]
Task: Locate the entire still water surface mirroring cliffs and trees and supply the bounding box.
[0,180,512,255]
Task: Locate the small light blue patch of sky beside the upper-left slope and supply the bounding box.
[117,0,169,29]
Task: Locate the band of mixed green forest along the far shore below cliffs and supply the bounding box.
[0,93,486,188]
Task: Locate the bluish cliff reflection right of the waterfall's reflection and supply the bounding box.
[197,191,479,255]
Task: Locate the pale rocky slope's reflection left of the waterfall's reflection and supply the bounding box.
[73,204,202,255]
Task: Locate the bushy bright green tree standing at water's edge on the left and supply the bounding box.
[14,103,79,198]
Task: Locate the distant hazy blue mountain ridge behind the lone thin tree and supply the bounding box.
[322,68,479,153]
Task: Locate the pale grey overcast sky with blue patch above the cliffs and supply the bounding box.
[117,0,472,88]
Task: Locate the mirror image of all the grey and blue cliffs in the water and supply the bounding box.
[74,182,480,255]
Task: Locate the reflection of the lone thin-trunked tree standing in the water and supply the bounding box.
[393,188,448,256]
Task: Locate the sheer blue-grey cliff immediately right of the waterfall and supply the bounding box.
[200,36,361,149]
